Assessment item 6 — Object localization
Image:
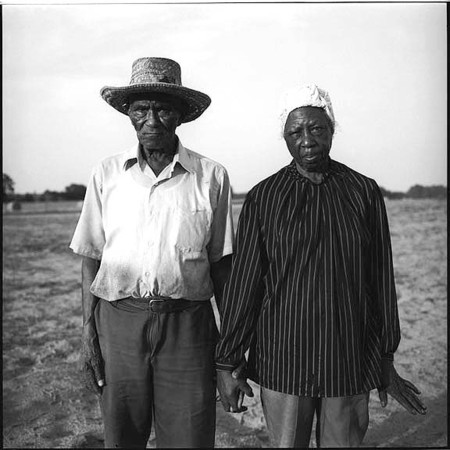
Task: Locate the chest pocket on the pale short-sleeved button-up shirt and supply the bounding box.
[174,208,212,259]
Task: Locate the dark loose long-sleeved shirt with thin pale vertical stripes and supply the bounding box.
[216,160,400,397]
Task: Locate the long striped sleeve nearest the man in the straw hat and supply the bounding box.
[216,196,267,370]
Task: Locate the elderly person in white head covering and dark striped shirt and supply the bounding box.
[216,85,426,447]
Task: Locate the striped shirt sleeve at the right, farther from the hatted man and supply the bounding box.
[370,184,400,359]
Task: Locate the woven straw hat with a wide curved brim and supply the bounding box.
[100,58,211,123]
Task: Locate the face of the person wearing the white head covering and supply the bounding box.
[283,106,333,172]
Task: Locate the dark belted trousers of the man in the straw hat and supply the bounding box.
[95,298,218,448]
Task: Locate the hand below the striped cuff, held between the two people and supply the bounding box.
[217,368,253,413]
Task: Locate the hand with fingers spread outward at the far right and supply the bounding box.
[378,360,427,415]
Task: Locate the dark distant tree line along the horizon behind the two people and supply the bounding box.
[3,173,447,203]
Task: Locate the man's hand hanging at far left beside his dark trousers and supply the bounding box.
[80,325,105,395]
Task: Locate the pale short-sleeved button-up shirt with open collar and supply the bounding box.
[70,142,234,301]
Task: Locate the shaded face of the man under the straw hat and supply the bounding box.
[128,94,183,151]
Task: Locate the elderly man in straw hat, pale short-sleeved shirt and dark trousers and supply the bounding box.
[70,58,233,448]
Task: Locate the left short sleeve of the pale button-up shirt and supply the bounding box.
[70,166,105,260]
